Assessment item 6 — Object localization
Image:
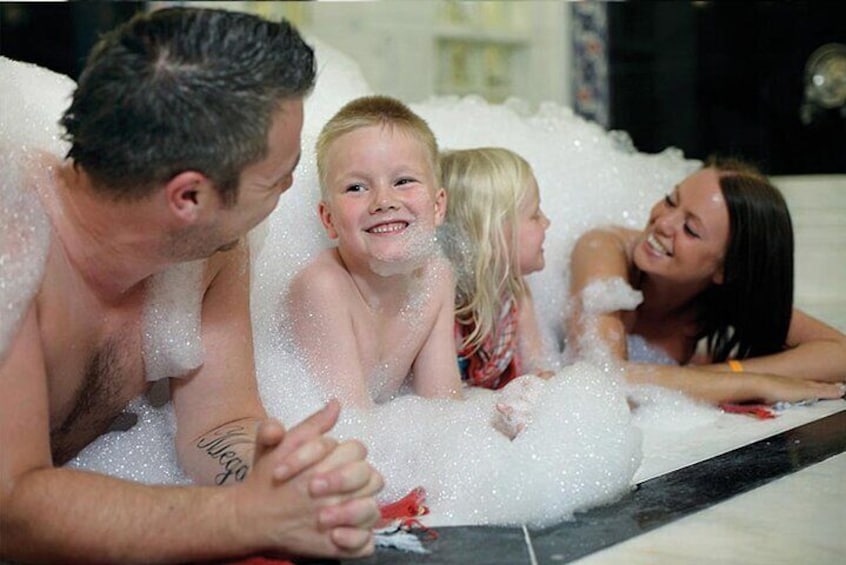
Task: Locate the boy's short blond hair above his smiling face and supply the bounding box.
[315,96,441,199]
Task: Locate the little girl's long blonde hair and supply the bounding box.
[441,147,534,350]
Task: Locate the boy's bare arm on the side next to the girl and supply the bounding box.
[411,262,461,399]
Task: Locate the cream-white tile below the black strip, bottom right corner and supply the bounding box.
[576,453,846,565]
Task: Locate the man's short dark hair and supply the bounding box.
[60,8,315,204]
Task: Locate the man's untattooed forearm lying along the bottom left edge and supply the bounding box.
[0,468,248,563]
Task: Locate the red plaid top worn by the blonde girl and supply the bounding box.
[455,298,521,389]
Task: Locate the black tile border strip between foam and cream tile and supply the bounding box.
[348,411,846,565]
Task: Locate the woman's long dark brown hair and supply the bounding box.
[700,157,793,362]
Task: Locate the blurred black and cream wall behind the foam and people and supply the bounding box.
[0,0,846,175]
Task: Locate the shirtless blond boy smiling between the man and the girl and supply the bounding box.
[288,96,461,408]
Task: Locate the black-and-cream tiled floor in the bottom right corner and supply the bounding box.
[342,410,846,565]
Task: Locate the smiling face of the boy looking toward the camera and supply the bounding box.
[319,126,446,274]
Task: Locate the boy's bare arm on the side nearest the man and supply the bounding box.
[287,257,374,408]
